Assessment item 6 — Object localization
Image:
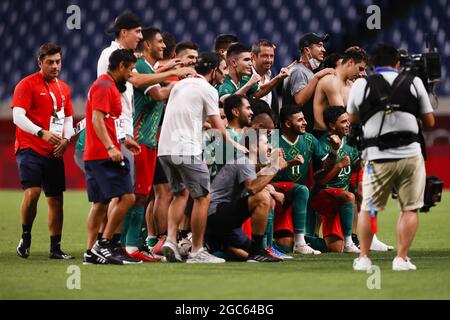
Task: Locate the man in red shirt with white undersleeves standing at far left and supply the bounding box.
[11,43,73,259]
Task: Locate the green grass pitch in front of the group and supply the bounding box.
[0,191,450,300]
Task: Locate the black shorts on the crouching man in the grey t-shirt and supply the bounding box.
[207,196,251,235]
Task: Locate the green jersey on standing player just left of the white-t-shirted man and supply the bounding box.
[133,58,164,149]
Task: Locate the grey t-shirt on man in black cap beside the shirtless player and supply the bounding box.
[283,62,314,132]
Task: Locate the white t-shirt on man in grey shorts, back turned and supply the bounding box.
[158,75,220,156]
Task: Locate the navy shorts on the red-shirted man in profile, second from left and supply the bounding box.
[84,158,134,203]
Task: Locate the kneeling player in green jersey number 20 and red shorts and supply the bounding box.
[311,106,360,253]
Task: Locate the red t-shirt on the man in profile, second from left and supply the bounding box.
[84,74,122,160]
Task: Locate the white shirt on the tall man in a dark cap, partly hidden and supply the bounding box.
[97,41,134,136]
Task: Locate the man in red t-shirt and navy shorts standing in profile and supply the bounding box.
[83,49,142,264]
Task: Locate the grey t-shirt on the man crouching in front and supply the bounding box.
[208,157,256,215]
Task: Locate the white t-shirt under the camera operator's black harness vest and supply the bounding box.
[347,70,433,160]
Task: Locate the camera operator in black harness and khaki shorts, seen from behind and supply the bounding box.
[347,44,434,270]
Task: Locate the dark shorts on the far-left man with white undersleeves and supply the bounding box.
[16,148,66,197]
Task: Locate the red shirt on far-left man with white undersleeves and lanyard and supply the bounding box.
[11,72,73,157]
